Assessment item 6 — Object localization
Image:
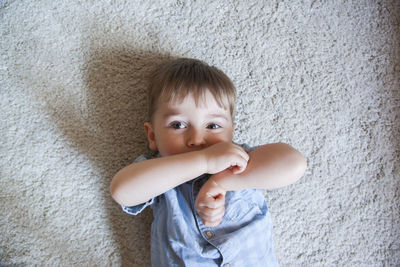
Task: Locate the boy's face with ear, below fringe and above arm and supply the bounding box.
[144,92,234,156]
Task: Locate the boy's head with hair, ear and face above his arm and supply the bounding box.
[145,58,236,156]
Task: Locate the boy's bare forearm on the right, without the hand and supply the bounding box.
[211,143,307,191]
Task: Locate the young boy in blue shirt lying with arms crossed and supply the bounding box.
[110,59,306,266]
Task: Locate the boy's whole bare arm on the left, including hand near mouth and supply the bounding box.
[110,142,248,206]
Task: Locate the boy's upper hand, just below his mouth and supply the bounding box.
[201,142,249,174]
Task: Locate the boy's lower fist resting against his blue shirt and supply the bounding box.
[195,178,226,227]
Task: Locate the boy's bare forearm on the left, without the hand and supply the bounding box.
[110,152,206,206]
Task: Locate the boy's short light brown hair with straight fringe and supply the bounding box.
[148,58,236,120]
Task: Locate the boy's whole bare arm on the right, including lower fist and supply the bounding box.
[195,143,307,227]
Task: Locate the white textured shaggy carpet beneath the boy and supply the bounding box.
[0,0,400,266]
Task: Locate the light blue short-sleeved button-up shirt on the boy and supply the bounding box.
[122,147,278,267]
